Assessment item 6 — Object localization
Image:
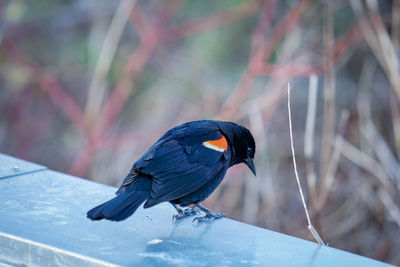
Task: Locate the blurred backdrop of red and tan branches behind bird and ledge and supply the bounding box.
[0,0,400,265]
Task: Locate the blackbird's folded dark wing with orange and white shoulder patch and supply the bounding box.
[134,122,231,206]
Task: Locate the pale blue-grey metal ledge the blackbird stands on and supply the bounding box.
[0,154,389,266]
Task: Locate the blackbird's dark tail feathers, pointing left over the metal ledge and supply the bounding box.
[87,177,151,221]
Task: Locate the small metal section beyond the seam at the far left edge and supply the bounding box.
[0,154,46,179]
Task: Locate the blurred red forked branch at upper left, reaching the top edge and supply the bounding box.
[98,1,258,140]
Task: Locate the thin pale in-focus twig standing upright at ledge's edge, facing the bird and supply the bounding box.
[288,83,325,245]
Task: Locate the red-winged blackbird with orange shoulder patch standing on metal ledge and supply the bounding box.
[87,120,256,221]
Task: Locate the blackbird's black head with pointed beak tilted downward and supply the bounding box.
[216,122,256,175]
